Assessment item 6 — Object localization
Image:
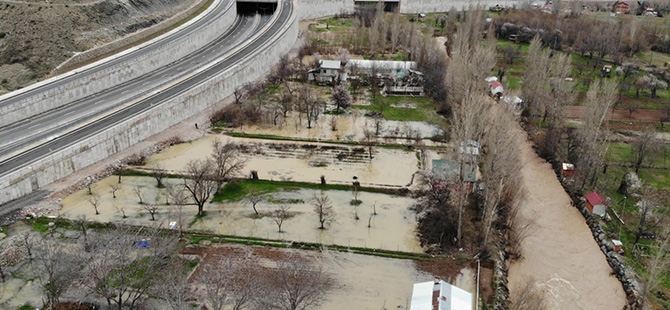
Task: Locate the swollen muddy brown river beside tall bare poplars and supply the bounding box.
[509,134,626,310]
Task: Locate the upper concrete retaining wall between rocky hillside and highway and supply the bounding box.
[0,0,237,127]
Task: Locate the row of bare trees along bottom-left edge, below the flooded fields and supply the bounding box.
[30,221,333,310]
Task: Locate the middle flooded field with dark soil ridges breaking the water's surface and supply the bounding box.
[146,135,418,187]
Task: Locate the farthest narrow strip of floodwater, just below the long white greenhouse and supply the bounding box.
[235,110,443,143]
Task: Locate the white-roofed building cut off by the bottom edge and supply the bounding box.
[409,278,473,310]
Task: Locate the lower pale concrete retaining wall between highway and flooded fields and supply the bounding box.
[0,0,298,204]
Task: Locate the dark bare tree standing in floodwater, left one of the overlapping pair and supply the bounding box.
[184,160,217,216]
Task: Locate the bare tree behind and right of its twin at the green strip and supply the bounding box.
[211,140,247,192]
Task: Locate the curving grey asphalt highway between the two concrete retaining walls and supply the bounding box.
[0,1,294,175]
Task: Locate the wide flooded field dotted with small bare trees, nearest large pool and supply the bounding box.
[58,176,423,253]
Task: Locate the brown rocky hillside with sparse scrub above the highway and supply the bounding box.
[0,0,194,94]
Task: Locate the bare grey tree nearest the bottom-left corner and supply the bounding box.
[35,236,81,307]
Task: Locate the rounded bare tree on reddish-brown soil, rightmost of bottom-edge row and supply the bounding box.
[257,256,333,310]
